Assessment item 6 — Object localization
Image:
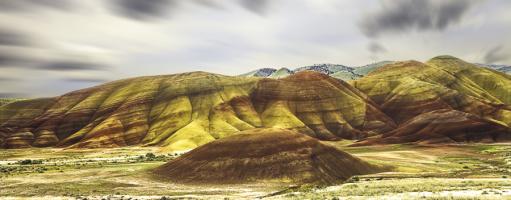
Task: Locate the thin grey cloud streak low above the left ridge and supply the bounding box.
[40,61,107,71]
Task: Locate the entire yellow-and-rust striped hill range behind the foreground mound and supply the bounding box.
[0,56,511,151]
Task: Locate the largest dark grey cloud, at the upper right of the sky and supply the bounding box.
[360,0,475,37]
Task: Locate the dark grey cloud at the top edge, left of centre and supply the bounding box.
[112,0,177,20]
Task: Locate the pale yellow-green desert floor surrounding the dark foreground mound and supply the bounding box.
[0,141,511,199]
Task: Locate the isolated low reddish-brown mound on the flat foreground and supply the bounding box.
[155,129,379,184]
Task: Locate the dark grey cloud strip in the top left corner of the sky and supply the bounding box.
[0,0,71,11]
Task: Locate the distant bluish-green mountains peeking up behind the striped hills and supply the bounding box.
[240,61,511,81]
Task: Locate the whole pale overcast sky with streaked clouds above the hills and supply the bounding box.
[0,0,511,97]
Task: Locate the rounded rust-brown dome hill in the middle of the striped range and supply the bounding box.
[251,71,395,140]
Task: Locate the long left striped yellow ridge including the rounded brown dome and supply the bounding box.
[0,71,395,151]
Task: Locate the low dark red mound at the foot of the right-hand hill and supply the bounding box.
[353,109,511,146]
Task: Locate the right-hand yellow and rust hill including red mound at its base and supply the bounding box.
[353,56,511,144]
